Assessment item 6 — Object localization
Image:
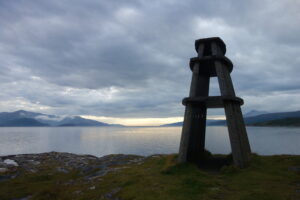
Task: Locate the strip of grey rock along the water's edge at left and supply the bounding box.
[0,152,145,175]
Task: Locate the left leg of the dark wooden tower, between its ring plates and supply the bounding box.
[178,45,209,163]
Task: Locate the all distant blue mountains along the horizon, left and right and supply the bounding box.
[0,110,300,127]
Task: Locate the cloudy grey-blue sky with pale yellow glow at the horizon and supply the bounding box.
[0,0,300,125]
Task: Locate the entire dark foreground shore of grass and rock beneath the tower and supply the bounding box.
[0,152,300,200]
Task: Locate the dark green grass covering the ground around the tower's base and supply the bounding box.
[0,155,300,200]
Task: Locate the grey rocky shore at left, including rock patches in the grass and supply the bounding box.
[0,152,145,200]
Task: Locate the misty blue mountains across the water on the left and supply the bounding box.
[0,110,110,126]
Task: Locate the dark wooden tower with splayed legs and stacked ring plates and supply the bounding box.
[178,37,251,168]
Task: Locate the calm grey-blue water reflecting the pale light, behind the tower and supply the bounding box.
[0,126,300,156]
